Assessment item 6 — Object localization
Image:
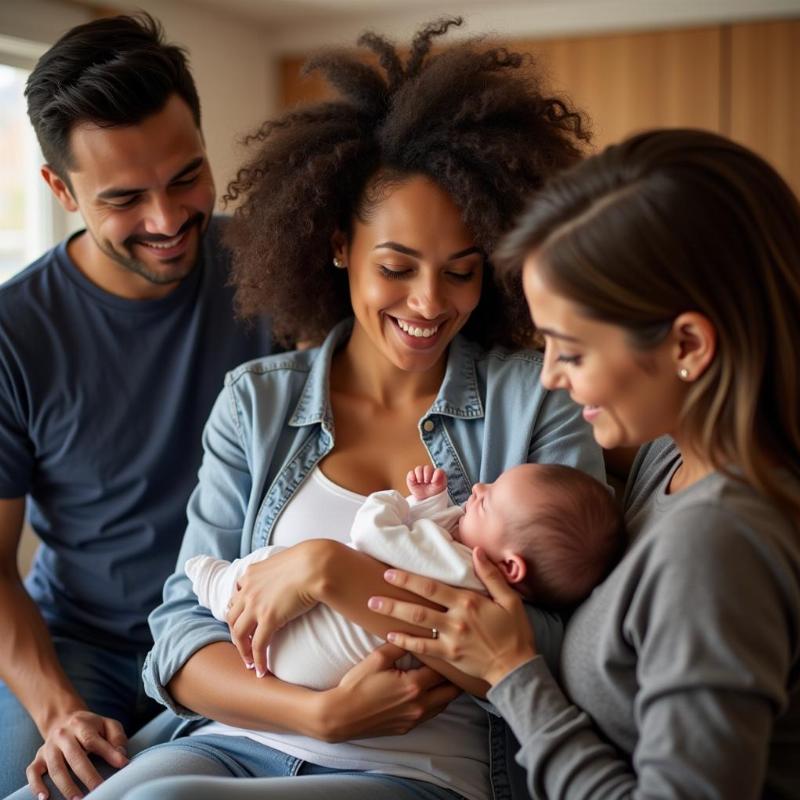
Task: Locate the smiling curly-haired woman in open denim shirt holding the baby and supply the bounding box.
[104,20,603,800]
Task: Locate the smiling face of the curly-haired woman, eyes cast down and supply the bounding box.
[342,175,483,373]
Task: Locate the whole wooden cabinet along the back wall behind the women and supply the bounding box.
[282,19,800,194]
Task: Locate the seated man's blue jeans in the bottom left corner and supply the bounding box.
[0,636,177,800]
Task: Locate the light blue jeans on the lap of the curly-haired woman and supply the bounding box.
[78,734,462,800]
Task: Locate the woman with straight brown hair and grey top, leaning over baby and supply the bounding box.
[370,130,800,800]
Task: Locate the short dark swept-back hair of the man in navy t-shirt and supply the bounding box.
[25,13,200,181]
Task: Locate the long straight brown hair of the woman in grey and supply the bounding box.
[493,129,800,519]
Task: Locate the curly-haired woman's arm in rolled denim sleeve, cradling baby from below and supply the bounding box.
[143,380,458,741]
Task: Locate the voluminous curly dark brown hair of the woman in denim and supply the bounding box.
[226,18,589,347]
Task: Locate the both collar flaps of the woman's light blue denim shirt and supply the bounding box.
[289,318,484,432]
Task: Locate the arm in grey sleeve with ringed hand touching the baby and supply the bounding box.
[372,509,800,800]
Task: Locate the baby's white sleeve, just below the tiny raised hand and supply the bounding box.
[350,490,485,591]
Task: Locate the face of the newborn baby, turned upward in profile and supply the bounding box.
[455,464,537,561]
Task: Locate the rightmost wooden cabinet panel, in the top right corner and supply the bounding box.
[726,20,800,194]
